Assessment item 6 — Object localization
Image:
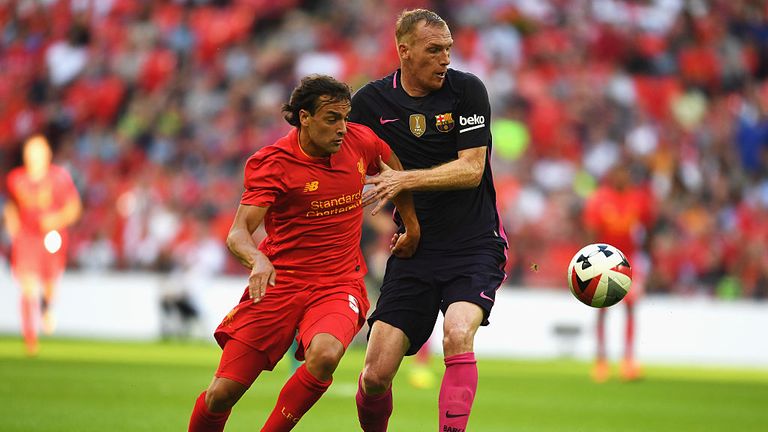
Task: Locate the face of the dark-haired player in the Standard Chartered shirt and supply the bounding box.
[299,97,352,157]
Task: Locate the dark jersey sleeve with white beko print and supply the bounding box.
[456,74,491,151]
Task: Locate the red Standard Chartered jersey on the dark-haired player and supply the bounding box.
[240,123,391,283]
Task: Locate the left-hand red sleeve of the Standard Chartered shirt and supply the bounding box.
[240,153,286,207]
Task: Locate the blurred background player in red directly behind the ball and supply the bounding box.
[583,164,654,382]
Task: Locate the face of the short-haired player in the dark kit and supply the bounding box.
[398,21,453,96]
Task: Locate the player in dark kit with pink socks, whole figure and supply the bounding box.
[350,9,507,432]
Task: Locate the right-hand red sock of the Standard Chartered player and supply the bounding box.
[261,364,333,432]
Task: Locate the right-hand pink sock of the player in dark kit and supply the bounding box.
[438,352,477,432]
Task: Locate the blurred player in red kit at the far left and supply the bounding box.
[3,135,82,356]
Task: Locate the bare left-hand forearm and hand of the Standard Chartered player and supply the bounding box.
[227,204,276,303]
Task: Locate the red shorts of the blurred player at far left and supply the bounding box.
[11,234,67,281]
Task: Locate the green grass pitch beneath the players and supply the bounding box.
[0,336,768,432]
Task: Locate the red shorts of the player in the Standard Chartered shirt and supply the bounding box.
[213,279,369,381]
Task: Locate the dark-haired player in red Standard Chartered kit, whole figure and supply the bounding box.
[189,75,420,432]
